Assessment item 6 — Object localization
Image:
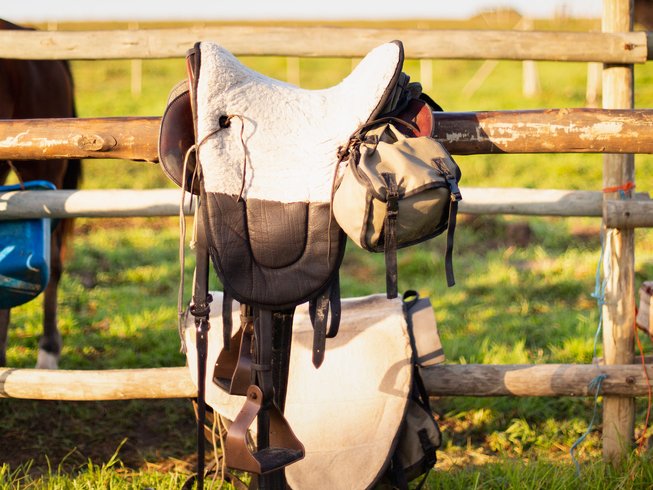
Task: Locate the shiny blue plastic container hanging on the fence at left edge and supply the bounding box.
[0,180,56,309]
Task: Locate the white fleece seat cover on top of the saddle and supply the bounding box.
[197,41,403,203]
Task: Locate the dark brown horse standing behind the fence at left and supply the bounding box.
[0,19,81,368]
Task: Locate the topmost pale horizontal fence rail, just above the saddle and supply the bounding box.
[0,26,648,63]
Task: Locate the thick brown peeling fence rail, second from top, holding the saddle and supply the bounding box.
[0,109,653,162]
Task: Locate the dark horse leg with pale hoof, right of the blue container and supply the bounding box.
[36,223,63,369]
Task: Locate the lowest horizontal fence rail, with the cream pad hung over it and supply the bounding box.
[0,364,653,401]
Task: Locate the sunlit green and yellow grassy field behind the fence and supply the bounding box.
[0,17,653,489]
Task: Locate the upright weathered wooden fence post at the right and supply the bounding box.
[602,0,635,463]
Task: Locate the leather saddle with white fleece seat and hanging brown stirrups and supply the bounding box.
[159,41,410,473]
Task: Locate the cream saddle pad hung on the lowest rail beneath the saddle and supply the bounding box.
[184,292,412,490]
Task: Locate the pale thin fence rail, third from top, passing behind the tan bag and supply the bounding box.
[0,187,628,220]
